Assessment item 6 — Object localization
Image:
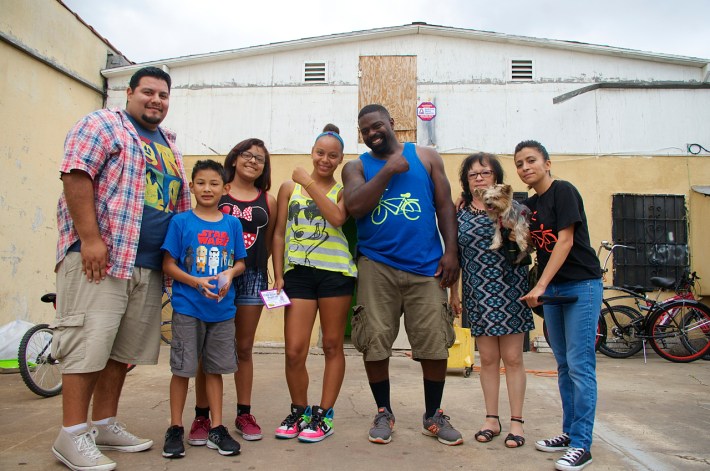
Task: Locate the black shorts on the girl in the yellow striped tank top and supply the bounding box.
[284,265,356,299]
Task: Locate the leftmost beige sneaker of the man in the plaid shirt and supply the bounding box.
[52,427,116,471]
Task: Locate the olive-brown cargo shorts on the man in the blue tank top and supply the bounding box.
[351,256,456,361]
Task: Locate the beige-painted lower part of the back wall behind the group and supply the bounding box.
[185,152,710,345]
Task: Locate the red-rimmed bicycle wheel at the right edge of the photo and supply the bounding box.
[646,301,710,363]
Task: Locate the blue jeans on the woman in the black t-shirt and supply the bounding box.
[544,279,602,450]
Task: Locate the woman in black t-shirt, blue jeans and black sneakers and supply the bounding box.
[514,141,602,470]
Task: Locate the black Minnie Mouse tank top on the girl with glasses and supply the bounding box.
[219,191,271,273]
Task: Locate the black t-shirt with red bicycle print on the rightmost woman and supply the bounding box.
[523,180,602,283]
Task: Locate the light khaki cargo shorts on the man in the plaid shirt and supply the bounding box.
[52,252,163,373]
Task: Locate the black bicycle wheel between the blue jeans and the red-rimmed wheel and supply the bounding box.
[599,306,643,358]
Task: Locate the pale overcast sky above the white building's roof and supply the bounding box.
[63,0,710,63]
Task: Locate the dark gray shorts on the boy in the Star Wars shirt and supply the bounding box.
[170,312,237,378]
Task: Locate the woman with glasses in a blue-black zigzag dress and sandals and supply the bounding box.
[450,153,535,448]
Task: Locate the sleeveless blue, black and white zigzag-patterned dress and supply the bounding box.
[456,207,535,336]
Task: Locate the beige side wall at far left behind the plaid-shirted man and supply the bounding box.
[0,0,126,325]
